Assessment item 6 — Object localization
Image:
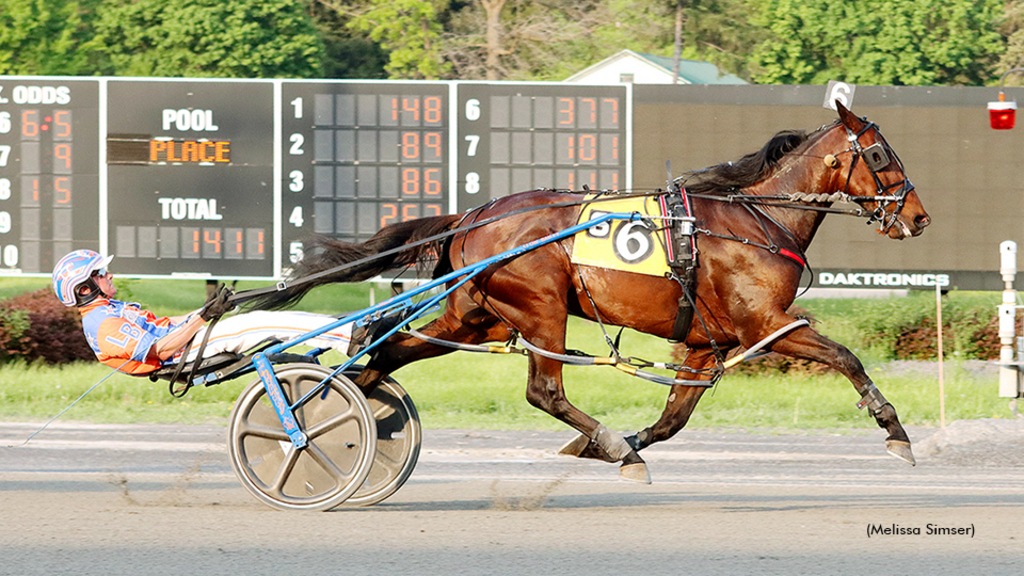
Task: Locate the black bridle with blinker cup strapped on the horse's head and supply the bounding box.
[837,120,913,236]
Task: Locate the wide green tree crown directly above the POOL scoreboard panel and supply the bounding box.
[96,0,324,78]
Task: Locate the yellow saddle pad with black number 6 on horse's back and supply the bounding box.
[571,195,669,277]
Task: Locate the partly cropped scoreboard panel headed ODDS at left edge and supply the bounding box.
[0,78,99,274]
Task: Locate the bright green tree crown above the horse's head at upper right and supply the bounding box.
[751,0,1002,85]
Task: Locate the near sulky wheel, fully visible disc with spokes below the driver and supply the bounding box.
[227,364,377,510]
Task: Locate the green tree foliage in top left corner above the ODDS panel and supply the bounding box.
[0,0,102,76]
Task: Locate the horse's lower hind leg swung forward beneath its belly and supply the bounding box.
[526,353,650,484]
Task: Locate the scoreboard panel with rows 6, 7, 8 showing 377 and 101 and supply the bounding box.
[457,83,630,209]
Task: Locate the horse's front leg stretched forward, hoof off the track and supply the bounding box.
[771,319,916,465]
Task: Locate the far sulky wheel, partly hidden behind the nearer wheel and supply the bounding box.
[344,365,423,506]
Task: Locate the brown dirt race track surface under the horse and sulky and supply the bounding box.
[0,420,1024,576]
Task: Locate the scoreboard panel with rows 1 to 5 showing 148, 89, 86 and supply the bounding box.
[282,82,451,266]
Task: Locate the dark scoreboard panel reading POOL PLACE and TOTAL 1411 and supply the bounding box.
[105,80,275,278]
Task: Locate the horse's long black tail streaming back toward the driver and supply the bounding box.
[248,214,462,310]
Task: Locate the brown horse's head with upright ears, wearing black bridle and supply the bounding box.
[825,101,932,240]
